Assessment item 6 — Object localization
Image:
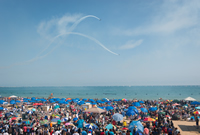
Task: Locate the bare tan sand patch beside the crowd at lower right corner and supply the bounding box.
[173,120,200,135]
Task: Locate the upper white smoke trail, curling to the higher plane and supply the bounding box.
[36,15,101,57]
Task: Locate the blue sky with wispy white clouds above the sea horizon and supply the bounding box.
[0,0,200,86]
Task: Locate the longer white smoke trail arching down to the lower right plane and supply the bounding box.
[0,32,119,69]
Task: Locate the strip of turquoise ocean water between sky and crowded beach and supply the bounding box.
[0,86,200,101]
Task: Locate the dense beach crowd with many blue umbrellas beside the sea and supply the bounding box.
[0,97,199,135]
